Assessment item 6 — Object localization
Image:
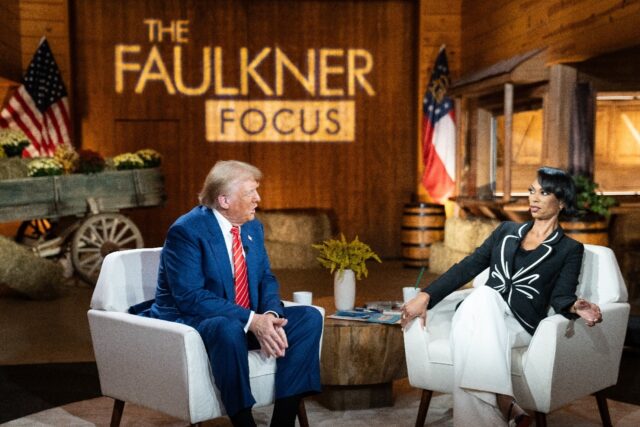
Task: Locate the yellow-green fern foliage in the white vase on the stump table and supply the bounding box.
[311,234,382,279]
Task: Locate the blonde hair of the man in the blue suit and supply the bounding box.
[198,160,262,208]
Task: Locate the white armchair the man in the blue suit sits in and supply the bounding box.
[88,248,324,426]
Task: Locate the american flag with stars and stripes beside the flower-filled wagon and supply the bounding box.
[0,38,71,157]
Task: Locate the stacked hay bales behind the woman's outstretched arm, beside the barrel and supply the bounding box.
[429,217,500,274]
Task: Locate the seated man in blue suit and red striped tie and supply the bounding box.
[150,160,322,426]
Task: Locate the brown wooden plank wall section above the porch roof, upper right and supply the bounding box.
[461,0,640,74]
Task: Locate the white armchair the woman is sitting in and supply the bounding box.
[404,245,629,427]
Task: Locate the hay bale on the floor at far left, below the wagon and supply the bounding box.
[0,236,63,299]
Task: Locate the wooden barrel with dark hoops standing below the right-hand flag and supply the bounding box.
[402,203,445,268]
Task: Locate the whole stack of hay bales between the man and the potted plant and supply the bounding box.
[256,210,331,269]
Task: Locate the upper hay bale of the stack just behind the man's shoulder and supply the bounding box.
[256,210,331,245]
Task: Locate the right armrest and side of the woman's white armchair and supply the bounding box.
[523,303,629,412]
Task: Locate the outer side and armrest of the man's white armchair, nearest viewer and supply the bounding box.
[88,310,224,422]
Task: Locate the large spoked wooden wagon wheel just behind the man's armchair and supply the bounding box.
[71,213,144,284]
